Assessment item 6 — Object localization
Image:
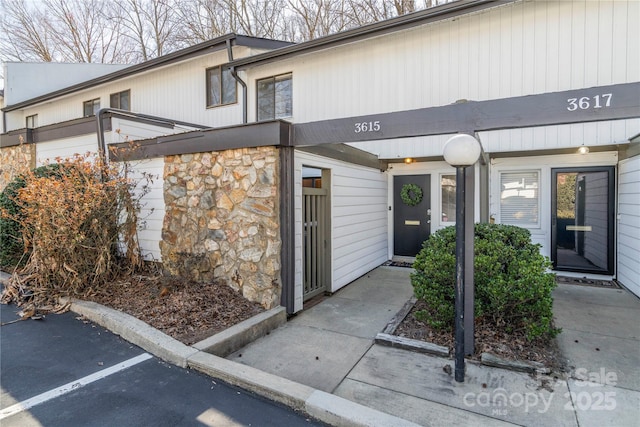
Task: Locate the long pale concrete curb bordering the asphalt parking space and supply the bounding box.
[63,300,418,427]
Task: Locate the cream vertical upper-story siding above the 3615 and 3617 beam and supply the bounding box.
[248,1,640,125]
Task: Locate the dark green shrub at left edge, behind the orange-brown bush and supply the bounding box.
[0,163,60,268]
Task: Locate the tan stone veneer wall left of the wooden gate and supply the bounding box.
[160,147,281,308]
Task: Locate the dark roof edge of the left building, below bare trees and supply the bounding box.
[3,33,291,112]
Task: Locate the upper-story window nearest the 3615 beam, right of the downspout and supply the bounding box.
[258,73,293,122]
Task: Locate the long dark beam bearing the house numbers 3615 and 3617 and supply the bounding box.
[293,82,640,146]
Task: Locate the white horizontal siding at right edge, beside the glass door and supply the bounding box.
[617,156,640,297]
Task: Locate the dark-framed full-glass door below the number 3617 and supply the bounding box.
[551,167,614,274]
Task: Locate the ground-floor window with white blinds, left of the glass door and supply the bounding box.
[500,171,540,227]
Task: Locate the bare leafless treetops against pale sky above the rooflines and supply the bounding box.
[0,0,455,63]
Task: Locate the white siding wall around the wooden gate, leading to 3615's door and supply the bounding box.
[295,151,388,311]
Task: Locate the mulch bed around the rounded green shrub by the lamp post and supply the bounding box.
[393,301,564,370]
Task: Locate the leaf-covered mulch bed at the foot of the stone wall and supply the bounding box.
[83,275,265,345]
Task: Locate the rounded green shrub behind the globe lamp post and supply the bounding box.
[411,224,559,340]
